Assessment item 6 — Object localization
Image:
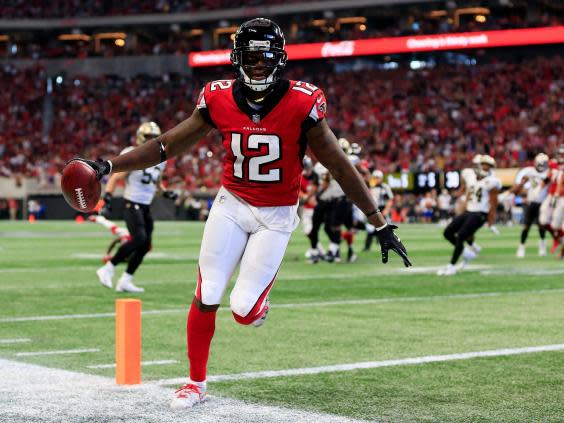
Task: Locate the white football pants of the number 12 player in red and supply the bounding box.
[196,188,299,317]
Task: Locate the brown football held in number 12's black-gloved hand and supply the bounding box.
[61,160,102,213]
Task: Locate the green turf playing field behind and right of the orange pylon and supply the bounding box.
[0,222,564,422]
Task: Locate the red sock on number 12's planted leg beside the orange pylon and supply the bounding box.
[186,301,217,382]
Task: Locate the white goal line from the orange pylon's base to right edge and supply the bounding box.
[150,344,564,385]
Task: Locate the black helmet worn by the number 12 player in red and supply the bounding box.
[231,18,288,92]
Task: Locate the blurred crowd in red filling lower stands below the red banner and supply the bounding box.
[0,56,564,184]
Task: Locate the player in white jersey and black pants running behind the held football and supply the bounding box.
[96,122,176,292]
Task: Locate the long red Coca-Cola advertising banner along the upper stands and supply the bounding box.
[188,26,564,67]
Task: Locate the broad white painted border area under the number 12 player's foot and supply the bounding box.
[0,359,368,423]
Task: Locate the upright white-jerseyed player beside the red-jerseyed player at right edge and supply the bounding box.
[511,153,549,258]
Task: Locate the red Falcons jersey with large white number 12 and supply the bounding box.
[197,80,327,207]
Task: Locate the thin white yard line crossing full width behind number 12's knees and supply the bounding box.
[0,288,564,323]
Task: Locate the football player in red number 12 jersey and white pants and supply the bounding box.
[74,18,411,409]
